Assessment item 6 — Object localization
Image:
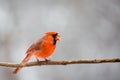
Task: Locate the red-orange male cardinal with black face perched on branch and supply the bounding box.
[13,32,60,74]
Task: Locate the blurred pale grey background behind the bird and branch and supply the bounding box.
[0,0,120,80]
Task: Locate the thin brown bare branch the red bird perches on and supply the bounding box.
[0,58,120,67]
